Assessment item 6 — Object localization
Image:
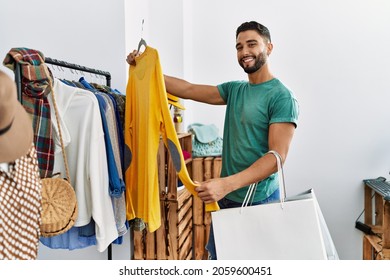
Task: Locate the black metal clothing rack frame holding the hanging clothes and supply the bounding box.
[15,57,112,260]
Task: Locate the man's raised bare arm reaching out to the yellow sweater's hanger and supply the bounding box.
[164,75,225,105]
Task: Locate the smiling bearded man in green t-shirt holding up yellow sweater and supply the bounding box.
[127,21,299,259]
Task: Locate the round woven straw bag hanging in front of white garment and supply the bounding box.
[41,178,78,237]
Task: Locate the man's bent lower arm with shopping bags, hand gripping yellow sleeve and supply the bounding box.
[195,123,295,203]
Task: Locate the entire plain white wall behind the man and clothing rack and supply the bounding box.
[0,0,390,259]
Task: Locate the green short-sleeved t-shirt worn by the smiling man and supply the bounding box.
[218,79,299,202]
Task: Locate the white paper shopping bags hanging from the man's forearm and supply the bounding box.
[211,151,338,260]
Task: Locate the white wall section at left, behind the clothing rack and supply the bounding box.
[0,0,130,260]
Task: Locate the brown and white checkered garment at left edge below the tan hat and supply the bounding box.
[0,143,42,260]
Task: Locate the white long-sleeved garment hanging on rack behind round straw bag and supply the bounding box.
[43,79,118,252]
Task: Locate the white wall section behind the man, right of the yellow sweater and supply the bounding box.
[130,0,390,259]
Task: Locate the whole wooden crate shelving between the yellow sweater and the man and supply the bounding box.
[133,133,222,260]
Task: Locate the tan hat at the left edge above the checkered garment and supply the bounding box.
[0,71,33,163]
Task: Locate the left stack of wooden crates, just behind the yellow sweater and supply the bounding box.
[134,133,194,260]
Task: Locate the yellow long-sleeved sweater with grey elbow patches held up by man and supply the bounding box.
[125,46,219,232]
